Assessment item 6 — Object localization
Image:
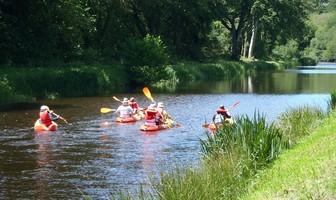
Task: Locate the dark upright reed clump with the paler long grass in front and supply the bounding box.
[143,114,284,199]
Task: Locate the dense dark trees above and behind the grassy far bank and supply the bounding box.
[0,0,336,67]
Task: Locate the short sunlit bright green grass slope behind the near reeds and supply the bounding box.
[244,112,336,199]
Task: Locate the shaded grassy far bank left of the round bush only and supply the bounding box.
[0,66,125,102]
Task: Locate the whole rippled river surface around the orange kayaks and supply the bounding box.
[0,65,336,199]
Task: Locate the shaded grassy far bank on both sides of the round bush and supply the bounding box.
[0,61,288,104]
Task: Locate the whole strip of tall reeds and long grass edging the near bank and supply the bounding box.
[128,107,325,199]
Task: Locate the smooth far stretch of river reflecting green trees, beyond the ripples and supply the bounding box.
[175,70,336,94]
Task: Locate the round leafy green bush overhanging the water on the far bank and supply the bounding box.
[121,35,169,85]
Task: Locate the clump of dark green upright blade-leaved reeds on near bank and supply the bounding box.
[201,114,287,169]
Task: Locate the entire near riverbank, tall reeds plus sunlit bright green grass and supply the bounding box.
[109,92,336,200]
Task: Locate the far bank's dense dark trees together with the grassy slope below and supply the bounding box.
[0,0,336,103]
